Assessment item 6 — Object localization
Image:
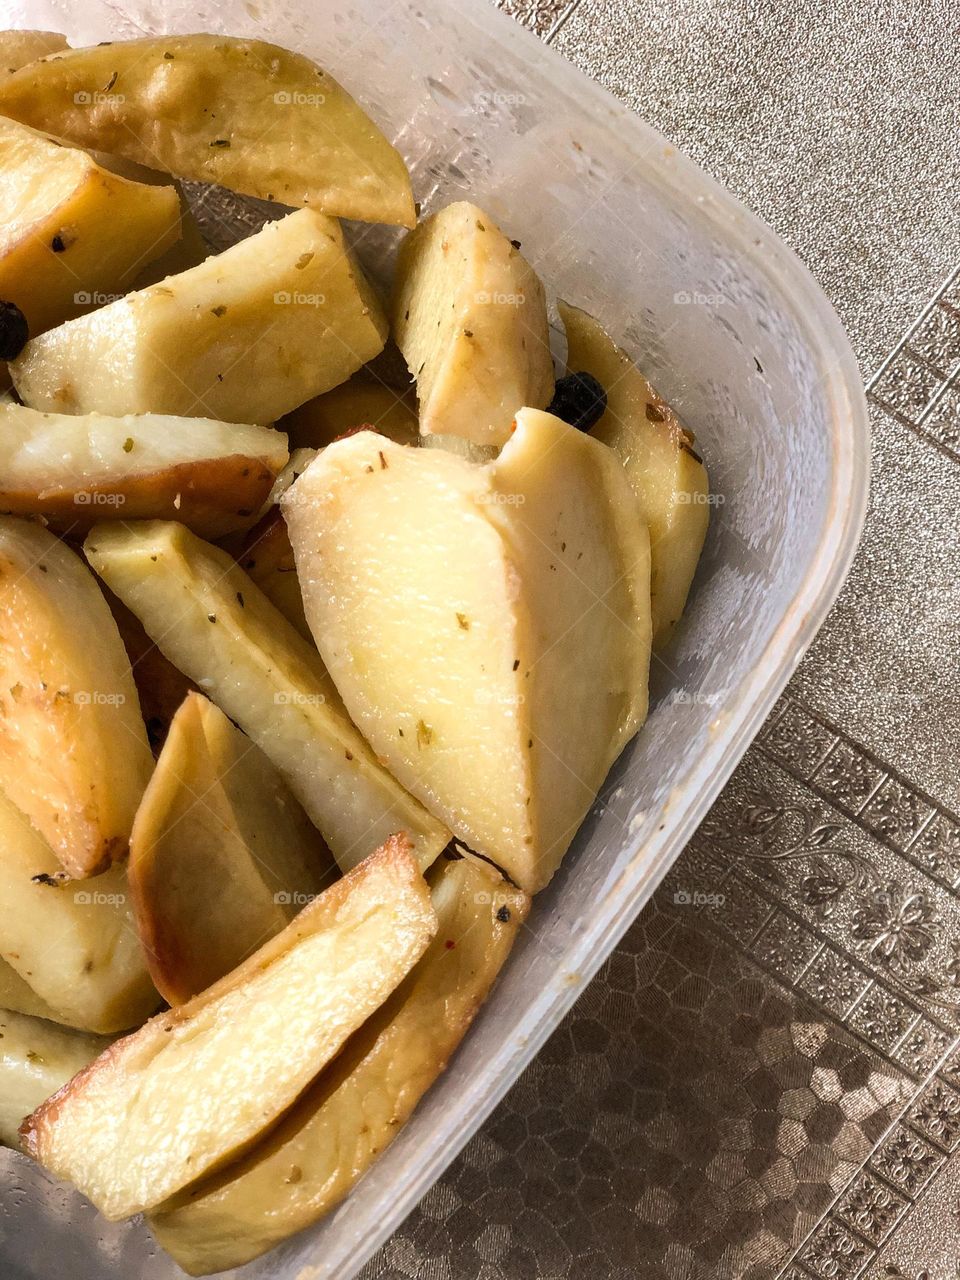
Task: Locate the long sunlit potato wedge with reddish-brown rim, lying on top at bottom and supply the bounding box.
[20,837,436,1219]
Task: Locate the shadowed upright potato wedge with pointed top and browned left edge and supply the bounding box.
[129,694,339,1005]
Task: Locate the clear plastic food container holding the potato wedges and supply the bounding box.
[0,0,868,1280]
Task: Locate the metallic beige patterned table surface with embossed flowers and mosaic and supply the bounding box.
[364,0,960,1280]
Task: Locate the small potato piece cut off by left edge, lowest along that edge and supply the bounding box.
[0,1009,108,1147]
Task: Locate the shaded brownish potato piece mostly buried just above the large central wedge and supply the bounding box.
[284,369,420,449]
